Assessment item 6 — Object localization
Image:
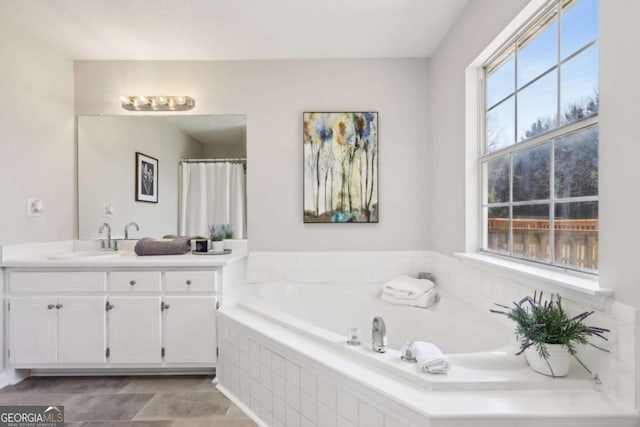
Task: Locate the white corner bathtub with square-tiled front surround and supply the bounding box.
[217,283,637,427]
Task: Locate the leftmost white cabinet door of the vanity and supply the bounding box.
[9,297,58,366]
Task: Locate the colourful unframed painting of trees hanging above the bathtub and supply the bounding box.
[302,112,379,223]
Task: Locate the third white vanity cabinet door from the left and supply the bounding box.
[108,296,162,364]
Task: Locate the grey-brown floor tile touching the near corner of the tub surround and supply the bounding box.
[135,392,231,420]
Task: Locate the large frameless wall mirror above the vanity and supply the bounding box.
[78,114,247,239]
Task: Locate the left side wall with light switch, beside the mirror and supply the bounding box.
[0,16,76,244]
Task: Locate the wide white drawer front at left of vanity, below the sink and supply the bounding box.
[9,271,107,293]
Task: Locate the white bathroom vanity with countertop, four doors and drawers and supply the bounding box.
[3,244,246,371]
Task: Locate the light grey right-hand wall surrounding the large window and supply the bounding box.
[429,0,640,407]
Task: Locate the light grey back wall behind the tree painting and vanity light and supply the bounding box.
[75,59,429,251]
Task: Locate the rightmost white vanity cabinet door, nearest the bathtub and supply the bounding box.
[164,296,216,364]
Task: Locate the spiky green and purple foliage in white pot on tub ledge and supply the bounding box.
[489,292,610,373]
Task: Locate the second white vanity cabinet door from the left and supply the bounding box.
[58,297,107,363]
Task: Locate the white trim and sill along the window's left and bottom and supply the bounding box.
[456,0,613,307]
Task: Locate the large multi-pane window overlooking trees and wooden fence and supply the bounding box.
[479,0,599,272]
